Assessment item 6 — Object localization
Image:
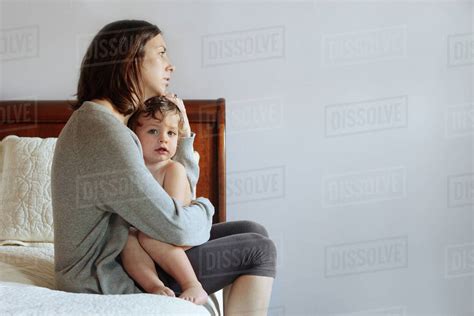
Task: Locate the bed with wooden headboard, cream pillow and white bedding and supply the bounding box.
[0,99,226,315]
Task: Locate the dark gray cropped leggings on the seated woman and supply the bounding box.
[152,221,276,296]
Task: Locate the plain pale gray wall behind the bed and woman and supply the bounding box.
[0,0,474,315]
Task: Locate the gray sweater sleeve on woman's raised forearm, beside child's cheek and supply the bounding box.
[173,132,199,196]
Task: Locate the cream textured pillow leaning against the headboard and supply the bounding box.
[0,136,56,242]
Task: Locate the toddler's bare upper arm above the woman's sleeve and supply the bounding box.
[163,161,191,205]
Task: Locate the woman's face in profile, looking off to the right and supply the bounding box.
[141,34,175,100]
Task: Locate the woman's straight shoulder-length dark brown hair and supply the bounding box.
[73,20,161,115]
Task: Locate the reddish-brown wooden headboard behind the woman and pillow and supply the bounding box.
[0,99,226,223]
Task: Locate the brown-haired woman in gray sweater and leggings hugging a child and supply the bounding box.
[51,20,276,315]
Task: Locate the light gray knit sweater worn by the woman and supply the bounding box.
[51,102,214,294]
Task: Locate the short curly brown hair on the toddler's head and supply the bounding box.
[127,97,184,135]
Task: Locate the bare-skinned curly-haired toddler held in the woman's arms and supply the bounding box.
[121,97,208,304]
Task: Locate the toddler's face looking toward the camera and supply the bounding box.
[135,112,179,165]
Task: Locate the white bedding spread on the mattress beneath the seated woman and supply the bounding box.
[0,243,218,315]
